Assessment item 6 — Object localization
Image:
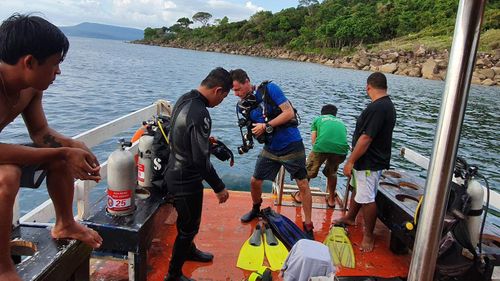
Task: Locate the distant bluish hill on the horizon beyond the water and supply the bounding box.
[59,22,144,41]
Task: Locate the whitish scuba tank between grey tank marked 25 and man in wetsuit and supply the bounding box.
[137,125,154,187]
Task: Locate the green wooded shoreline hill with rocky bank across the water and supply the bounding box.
[134,0,500,86]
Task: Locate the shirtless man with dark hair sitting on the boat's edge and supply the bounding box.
[0,14,102,281]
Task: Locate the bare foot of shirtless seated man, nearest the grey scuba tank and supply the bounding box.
[52,221,102,249]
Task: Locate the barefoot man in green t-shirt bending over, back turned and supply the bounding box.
[306,104,349,208]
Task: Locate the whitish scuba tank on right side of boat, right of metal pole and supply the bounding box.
[467,166,484,247]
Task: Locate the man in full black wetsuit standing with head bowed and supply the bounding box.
[165,67,233,281]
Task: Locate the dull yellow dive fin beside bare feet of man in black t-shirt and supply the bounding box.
[324,223,356,268]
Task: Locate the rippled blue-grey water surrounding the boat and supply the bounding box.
[0,37,500,214]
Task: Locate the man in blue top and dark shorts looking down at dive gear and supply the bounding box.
[231,69,314,239]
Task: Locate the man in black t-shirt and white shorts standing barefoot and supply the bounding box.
[336,72,396,252]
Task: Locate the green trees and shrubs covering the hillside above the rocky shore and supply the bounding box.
[144,0,500,55]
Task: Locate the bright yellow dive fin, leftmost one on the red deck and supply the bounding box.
[236,224,264,271]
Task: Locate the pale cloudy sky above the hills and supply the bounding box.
[0,0,299,29]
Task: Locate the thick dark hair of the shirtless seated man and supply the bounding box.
[0,13,69,65]
